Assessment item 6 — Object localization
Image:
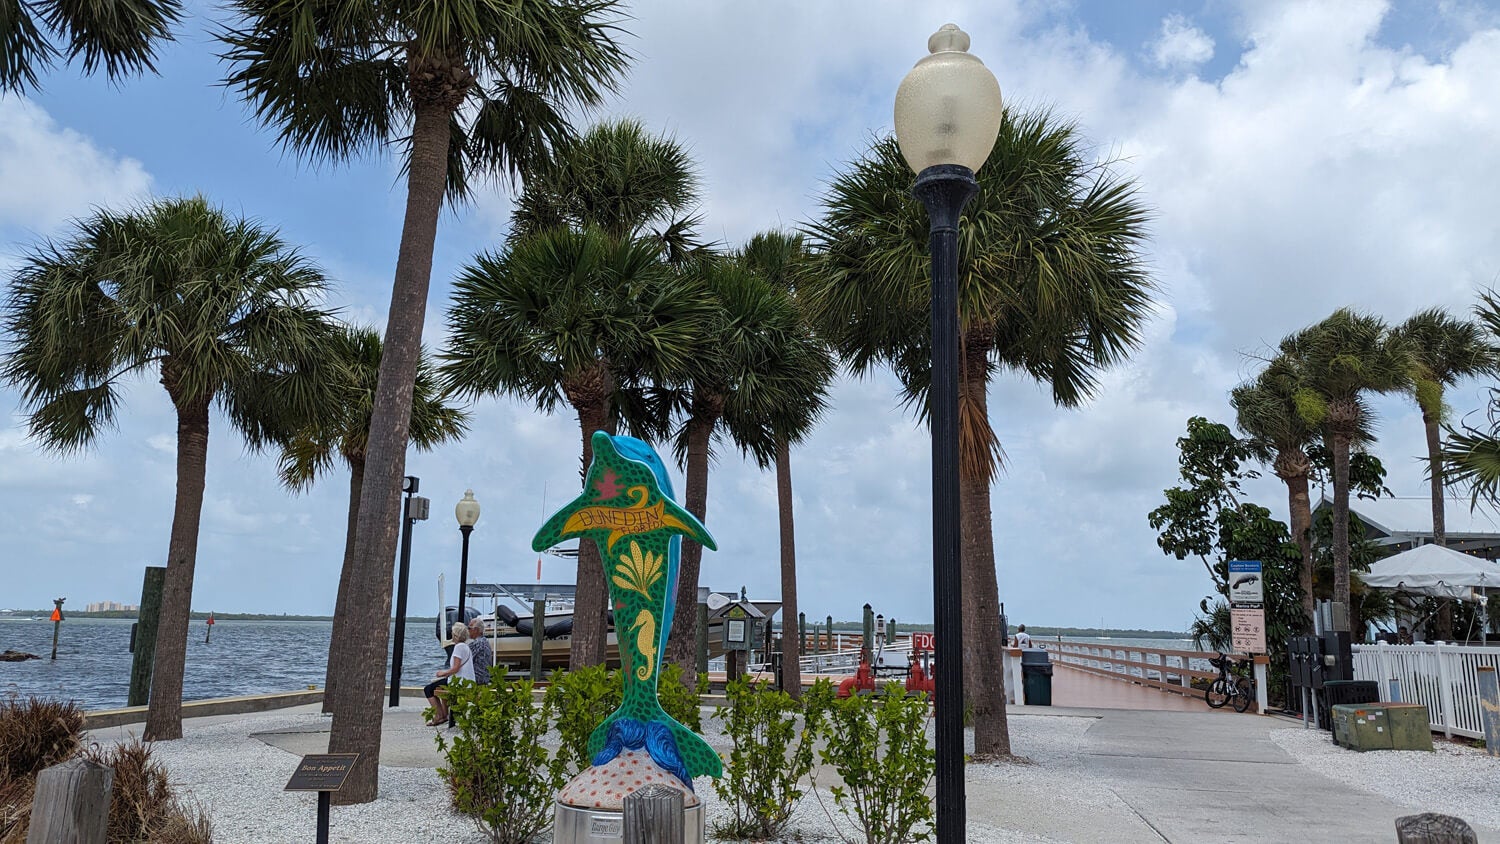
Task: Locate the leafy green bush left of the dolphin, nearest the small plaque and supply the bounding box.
[437,672,567,844]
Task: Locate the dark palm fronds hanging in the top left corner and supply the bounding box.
[0,0,182,94]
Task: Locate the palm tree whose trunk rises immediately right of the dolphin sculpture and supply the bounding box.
[660,258,821,676]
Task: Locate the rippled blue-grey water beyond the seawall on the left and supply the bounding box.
[0,618,444,709]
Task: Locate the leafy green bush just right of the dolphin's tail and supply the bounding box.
[714,678,834,840]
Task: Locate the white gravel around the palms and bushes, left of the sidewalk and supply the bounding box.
[123,712,1098,844]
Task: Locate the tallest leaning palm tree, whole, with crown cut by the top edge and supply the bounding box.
[219,0,627,804]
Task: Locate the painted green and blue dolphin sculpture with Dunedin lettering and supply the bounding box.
[531,430,723,789]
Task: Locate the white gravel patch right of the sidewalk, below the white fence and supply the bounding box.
[1271,729,1500,828]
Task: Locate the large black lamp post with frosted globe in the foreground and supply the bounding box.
[896,24,1001,844]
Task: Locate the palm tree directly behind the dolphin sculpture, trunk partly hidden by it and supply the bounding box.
[440,228,705,667]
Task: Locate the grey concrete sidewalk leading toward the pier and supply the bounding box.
[968,708,1500,844]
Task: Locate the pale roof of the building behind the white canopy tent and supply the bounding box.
[1313,496,1500,559]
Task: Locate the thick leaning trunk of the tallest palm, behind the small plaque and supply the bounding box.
[329,99,456,805]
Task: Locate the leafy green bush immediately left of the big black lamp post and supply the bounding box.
[813,682,935,844]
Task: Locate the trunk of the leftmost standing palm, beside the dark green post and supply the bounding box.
[143,396,209,742]
